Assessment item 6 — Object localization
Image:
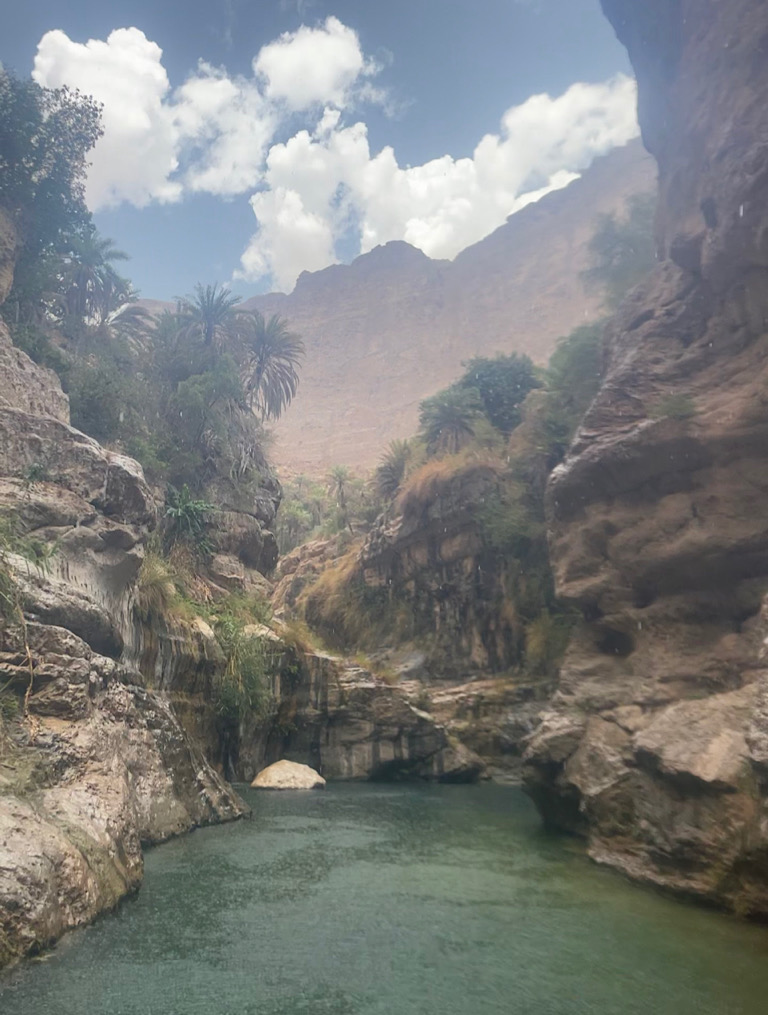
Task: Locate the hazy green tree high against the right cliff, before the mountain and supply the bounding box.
[582,194,656,310]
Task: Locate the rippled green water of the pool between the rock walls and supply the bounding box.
[0,785,768,1015]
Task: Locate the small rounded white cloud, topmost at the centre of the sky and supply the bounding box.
[254,17,377,112]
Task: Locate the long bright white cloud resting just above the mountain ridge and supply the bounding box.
[240,75,638,288]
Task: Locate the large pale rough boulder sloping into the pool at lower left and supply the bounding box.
[0,623,243,966]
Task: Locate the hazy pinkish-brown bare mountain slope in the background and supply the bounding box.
[246,142,654,473]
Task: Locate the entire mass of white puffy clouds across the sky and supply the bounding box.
[33,17,638,289]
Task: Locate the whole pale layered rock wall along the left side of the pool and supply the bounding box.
[0,290,243,966]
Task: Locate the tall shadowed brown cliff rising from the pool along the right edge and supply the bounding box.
[528,0,768,915]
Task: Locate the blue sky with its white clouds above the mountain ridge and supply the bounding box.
[0,0,638,299]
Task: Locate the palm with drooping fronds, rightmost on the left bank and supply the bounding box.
[242,311,304,420]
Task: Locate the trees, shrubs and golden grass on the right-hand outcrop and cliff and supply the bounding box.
[283,190,653,677]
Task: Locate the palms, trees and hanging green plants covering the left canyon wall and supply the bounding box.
[0,71,303,742]
